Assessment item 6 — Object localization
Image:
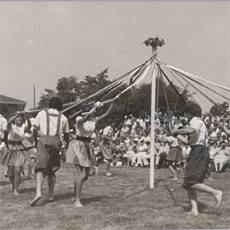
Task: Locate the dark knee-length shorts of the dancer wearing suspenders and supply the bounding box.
[35,136,61,175]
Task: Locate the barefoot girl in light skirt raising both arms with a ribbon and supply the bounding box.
[66,102,113,208]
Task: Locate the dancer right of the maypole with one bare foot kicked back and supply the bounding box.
[172,102,222,216]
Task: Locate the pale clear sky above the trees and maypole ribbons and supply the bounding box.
[0,0,230,109]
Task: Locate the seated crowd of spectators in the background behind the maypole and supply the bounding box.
[91,112,230,172]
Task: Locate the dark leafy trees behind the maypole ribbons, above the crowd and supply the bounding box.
[36,68,195,127]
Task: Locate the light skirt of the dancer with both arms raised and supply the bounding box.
[66,140,95,168]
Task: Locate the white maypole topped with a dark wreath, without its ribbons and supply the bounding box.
[144,37,164,189]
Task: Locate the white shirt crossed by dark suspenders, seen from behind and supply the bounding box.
[34,108,69,136]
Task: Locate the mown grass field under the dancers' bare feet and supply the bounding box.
[0,164,230,230]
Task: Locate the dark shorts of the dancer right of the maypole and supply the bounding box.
[183,145,209,189]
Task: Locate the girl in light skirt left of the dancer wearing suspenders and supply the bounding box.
[7,114,33,195]
